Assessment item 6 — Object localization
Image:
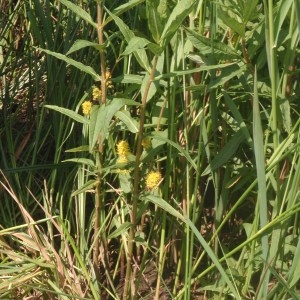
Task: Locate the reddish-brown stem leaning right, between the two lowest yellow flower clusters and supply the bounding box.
[123,56,158,300]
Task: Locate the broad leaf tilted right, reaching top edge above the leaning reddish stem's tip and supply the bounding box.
[160,0,195,48]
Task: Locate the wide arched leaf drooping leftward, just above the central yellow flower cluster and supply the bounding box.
[89,98,140,152]
